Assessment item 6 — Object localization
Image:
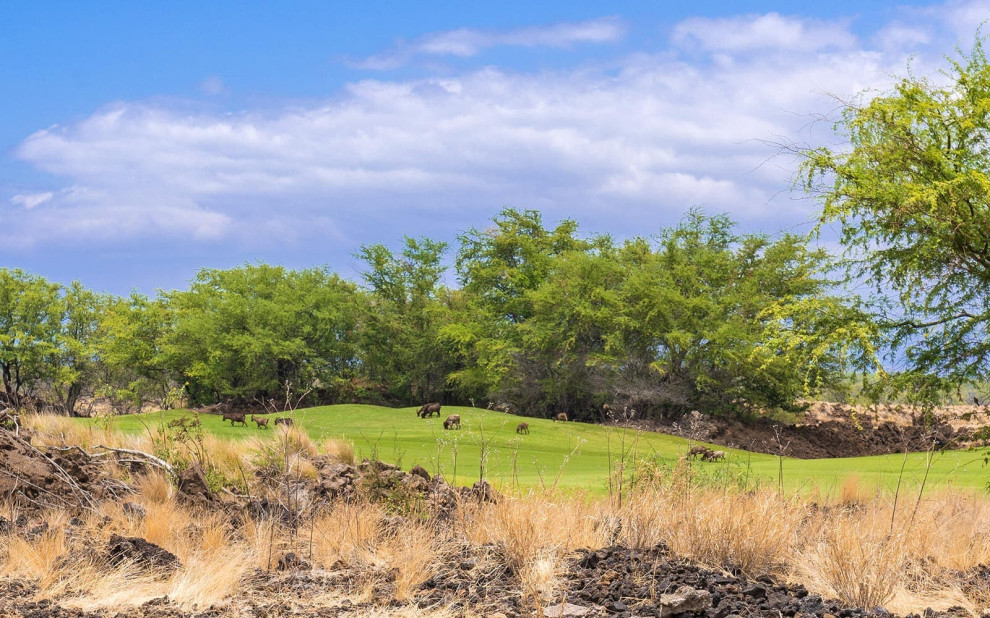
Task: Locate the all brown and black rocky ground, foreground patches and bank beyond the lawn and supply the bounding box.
[0,418,990,618]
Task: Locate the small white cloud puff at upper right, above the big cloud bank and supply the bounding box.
[673,13,856,52]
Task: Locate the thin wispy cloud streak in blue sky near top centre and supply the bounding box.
[350,17,625,70]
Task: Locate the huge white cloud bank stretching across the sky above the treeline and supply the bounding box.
[0,5,976,250]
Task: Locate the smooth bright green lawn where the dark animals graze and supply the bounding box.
[79,405,990,493]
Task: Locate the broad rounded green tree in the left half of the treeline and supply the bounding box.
[165,264,357,402]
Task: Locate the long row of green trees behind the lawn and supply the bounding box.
[0,209,872,420]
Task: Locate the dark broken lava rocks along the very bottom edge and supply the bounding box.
[0,546,987,618]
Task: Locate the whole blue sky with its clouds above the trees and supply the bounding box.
[0,0,990,294]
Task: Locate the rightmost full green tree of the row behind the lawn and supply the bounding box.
[611,211,860,415]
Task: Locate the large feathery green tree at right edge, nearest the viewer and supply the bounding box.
[801,38,990,403]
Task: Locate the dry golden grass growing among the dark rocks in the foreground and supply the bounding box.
[0,416,990,616]
